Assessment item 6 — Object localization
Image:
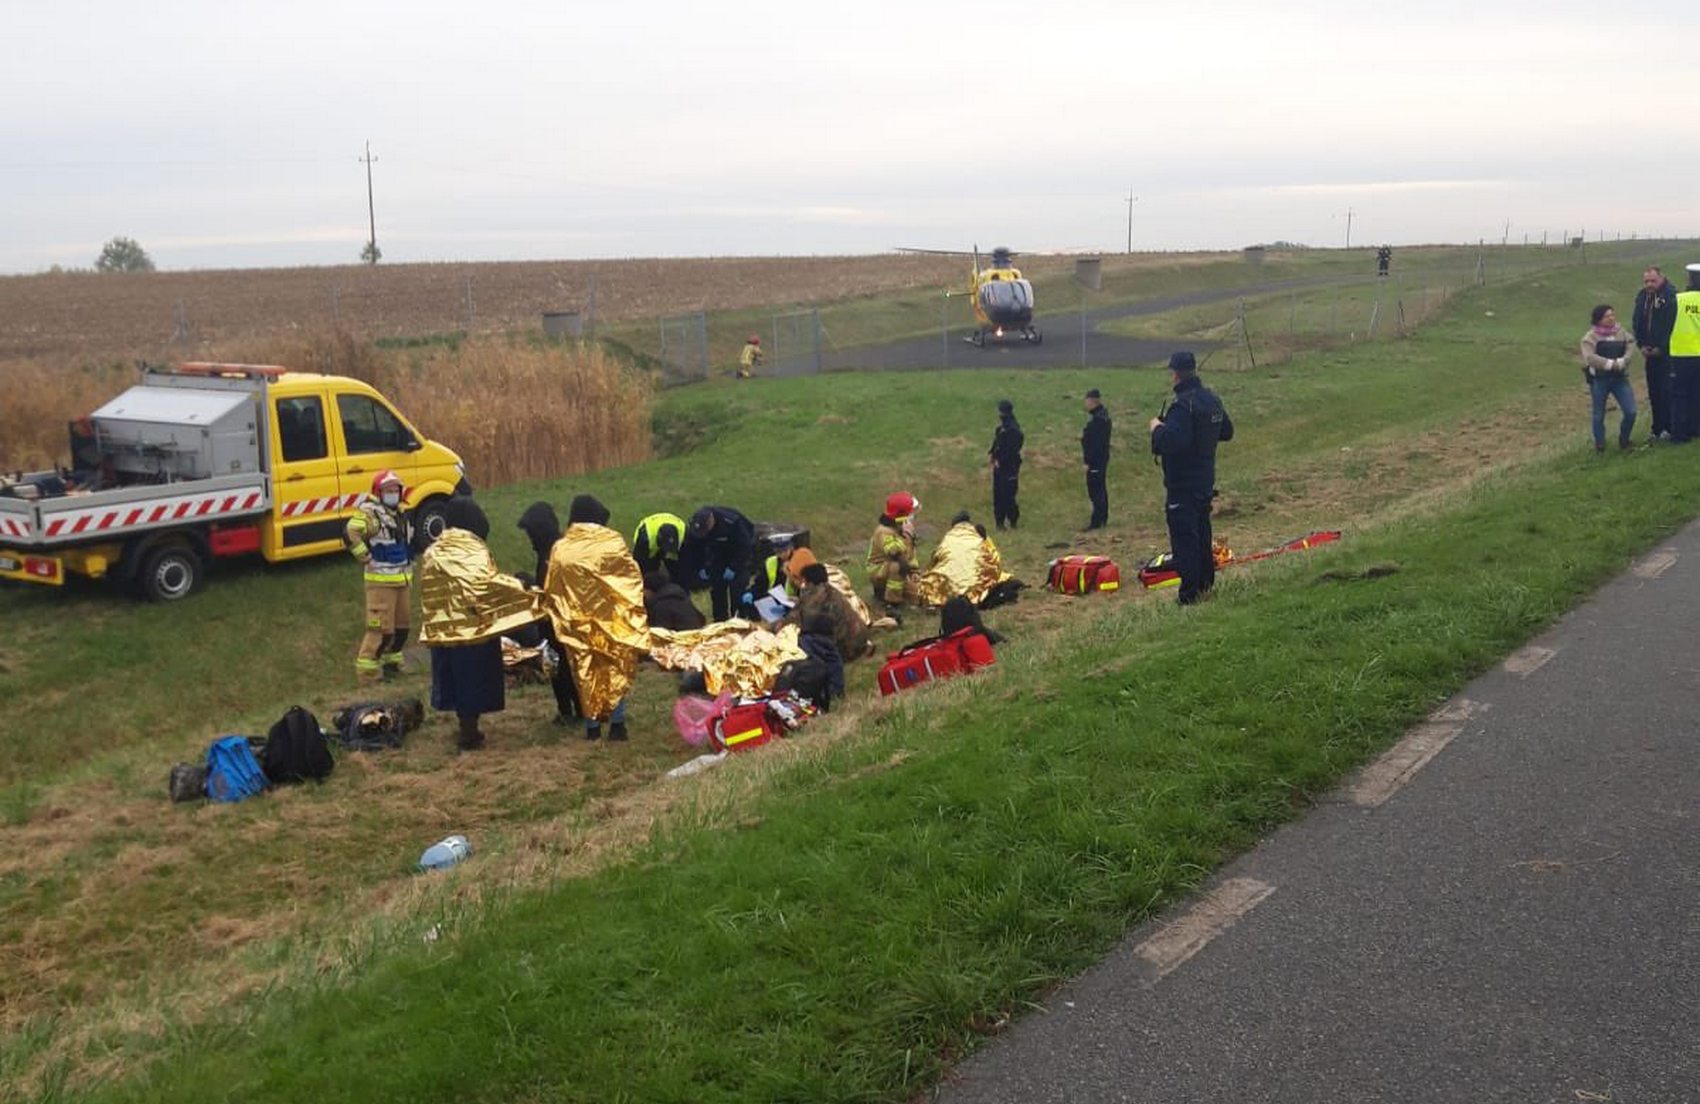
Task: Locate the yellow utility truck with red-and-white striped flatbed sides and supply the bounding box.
[0,364,473,602]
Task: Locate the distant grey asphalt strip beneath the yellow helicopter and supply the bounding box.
[762,277,1353,376]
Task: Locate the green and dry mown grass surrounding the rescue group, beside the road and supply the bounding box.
[0,248,1700,1101]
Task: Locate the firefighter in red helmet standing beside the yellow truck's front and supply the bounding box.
[343,471,413,686]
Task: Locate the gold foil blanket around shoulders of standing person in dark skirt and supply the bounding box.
[420,529,542,646]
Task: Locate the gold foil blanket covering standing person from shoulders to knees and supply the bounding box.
[544,522,649,720]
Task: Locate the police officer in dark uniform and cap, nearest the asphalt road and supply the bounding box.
[1151,352,1234,606]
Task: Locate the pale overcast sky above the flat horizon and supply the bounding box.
[0,0,1700,272]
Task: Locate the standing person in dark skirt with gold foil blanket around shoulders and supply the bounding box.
[420,495,541,752]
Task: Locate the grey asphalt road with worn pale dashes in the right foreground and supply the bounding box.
[935,526,1700,1104]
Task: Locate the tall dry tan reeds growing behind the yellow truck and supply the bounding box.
[0,330,651,487]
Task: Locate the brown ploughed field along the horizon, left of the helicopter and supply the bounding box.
[0,253,1073,358]
